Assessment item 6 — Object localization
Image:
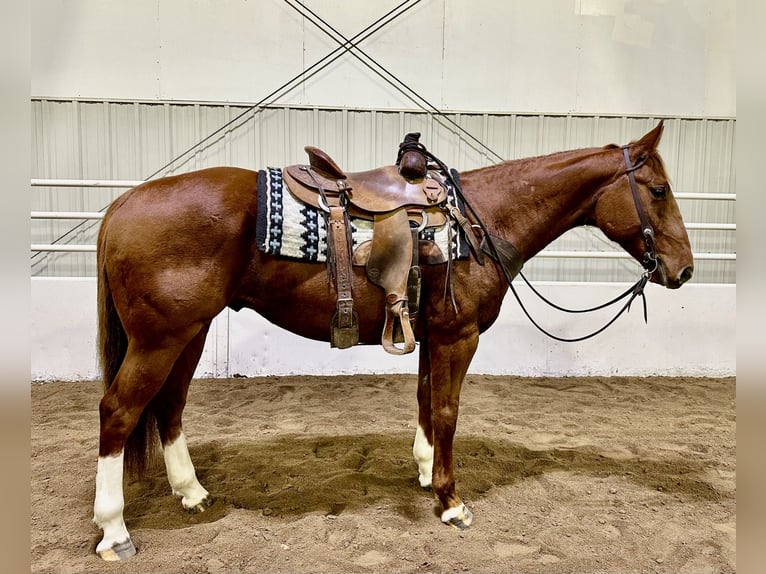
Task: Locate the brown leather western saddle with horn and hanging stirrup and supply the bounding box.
[284,133,480,355]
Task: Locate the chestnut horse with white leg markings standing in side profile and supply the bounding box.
[94,123,693,560]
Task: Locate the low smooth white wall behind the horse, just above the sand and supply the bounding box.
[31,278,736,380]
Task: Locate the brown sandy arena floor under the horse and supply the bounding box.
[31,375,736,574]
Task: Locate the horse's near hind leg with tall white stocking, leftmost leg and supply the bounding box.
[93,334,202,560]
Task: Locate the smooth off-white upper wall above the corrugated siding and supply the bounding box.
[32,0,736,117]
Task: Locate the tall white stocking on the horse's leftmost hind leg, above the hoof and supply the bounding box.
[93,451,130,553]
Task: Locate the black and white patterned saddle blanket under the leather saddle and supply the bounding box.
[255,167,470,263]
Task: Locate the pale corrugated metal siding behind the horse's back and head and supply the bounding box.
[31,100,736,283]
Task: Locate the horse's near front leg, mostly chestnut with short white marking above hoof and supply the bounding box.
[428,333,479,529]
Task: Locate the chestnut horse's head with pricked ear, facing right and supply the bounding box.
[595,122,694,289]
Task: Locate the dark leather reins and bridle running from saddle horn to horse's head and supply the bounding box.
[419,145,659,343]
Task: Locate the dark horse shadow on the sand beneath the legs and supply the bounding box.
[125,434,721,529]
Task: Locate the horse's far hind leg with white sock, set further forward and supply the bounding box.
[151,323,213,513]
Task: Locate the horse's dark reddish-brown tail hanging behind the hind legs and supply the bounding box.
[96,210,157,477]
